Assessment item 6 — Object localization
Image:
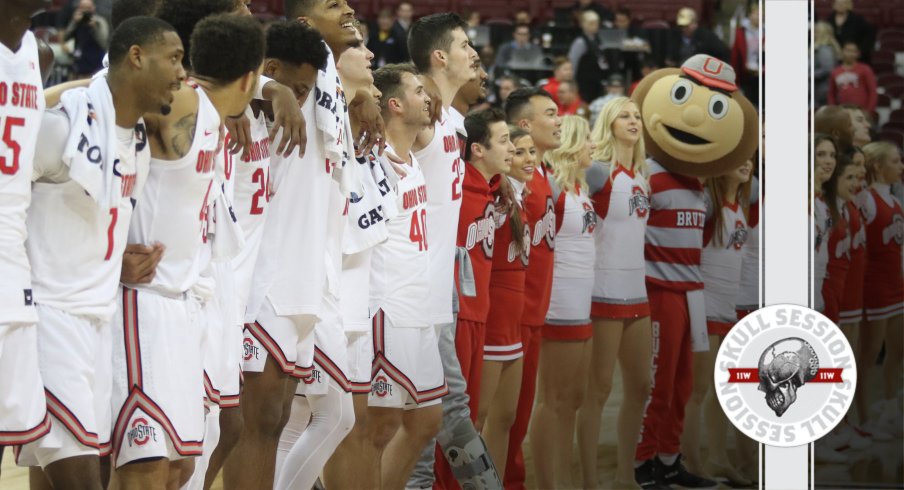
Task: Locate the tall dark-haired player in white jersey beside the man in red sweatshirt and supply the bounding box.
[406,13,499,488]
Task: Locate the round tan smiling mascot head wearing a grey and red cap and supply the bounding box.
[633,54,759,177]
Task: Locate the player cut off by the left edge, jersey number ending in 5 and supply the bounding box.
[0,0,50,474]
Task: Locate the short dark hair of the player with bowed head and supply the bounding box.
[267,20,329,70]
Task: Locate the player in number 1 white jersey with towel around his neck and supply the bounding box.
[19,17,185,488]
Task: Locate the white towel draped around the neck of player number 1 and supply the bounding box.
[60,78,126,208]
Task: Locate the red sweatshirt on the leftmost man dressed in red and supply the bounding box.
[456,163,499,323]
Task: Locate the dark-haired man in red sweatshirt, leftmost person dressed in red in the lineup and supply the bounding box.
[455,109,515,424]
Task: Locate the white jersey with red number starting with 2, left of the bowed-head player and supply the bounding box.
[231,107,270,323]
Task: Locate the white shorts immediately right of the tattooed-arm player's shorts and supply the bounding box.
[201,299,242,408]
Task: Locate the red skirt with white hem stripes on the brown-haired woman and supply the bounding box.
[483,280,524,361]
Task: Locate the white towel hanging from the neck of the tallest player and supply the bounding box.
[314,43,364,197]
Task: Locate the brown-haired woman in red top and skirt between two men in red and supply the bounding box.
[476,126,537,475]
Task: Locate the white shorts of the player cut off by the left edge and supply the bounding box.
[0,323,50,446]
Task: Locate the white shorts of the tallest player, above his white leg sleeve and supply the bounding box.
[295,297,352,396]
